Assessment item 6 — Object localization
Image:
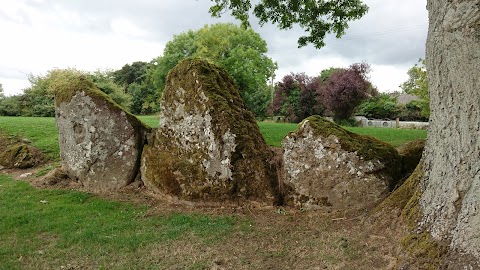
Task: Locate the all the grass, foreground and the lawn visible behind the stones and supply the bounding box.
[0,116,416,270]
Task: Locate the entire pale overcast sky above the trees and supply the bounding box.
[0,0,428,95]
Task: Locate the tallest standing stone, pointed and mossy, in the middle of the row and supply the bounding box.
[142,59,280,203]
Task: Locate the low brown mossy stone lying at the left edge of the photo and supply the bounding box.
[0,143,43,169]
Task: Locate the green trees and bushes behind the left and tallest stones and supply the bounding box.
[0,23,277,116]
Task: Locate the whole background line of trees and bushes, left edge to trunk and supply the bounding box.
[0,23,429,122]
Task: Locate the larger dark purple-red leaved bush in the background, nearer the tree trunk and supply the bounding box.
[317,63,375,119]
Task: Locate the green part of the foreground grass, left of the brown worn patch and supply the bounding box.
[0,174,244,269]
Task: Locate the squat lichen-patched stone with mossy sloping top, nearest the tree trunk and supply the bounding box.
[282,116,401,210]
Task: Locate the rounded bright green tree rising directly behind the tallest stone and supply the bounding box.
[154,23,277,115]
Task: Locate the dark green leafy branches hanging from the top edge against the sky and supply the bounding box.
[210,0,368,48]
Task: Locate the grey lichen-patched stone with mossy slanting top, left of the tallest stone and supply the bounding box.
[55,76,149,191]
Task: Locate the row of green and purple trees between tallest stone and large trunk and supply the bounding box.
[268,59,430,124]
